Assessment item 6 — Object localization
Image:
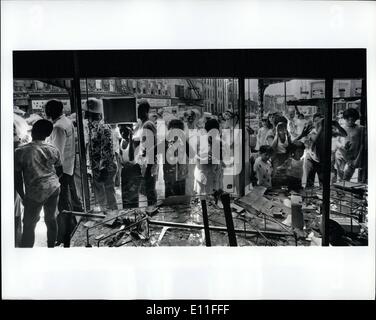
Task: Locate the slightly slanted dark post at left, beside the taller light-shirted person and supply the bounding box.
[72,52,90,210]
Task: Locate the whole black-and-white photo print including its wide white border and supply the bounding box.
[1,1,376,300]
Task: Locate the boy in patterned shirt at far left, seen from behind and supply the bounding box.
[14,119,63,248]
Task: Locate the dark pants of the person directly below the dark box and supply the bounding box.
[121,163,142,209]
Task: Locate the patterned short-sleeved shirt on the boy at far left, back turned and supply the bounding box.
[14,141,61,203]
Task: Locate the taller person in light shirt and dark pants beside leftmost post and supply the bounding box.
[45,100,77,247]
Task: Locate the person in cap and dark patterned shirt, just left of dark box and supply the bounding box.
[83,98,117,211]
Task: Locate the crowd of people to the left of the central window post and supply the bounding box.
[14,98,239,247]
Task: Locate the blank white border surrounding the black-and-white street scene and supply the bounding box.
[1,0,376,300]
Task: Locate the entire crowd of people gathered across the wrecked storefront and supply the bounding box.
[14,98,366,247]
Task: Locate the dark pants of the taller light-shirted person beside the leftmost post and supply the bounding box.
[57,173,77,247]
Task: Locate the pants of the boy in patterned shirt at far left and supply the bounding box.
[21,188,60,248]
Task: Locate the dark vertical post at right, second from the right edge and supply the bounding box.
[320,77,333,246]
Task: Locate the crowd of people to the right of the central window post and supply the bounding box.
[250,107,367,191]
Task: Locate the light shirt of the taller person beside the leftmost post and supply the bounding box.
[47,115,76,176]
